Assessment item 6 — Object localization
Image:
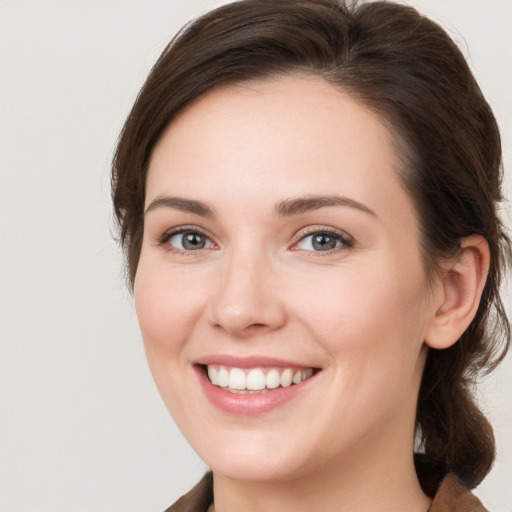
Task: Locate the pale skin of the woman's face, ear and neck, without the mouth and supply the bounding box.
[135,76,489,512]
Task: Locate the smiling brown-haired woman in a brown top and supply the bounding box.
[113,0,510,512]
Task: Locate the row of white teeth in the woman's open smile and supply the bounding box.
[207,365,313,393]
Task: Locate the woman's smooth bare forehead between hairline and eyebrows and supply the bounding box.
[146,76,414,226]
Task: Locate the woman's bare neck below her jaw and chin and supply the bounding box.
[212,426,431,512]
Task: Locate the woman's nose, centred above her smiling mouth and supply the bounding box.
[209,249,286,339]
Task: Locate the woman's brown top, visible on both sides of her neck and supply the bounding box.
[165,472,488,512]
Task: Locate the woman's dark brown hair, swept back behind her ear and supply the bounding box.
[112,0,510,495]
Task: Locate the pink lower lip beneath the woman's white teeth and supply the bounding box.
[197,368,315,416]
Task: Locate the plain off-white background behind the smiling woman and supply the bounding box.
[0,0,512,512]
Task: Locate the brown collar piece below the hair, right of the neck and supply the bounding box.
[428,473,488,512]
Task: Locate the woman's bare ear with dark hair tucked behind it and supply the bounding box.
[425,235,490,349]
